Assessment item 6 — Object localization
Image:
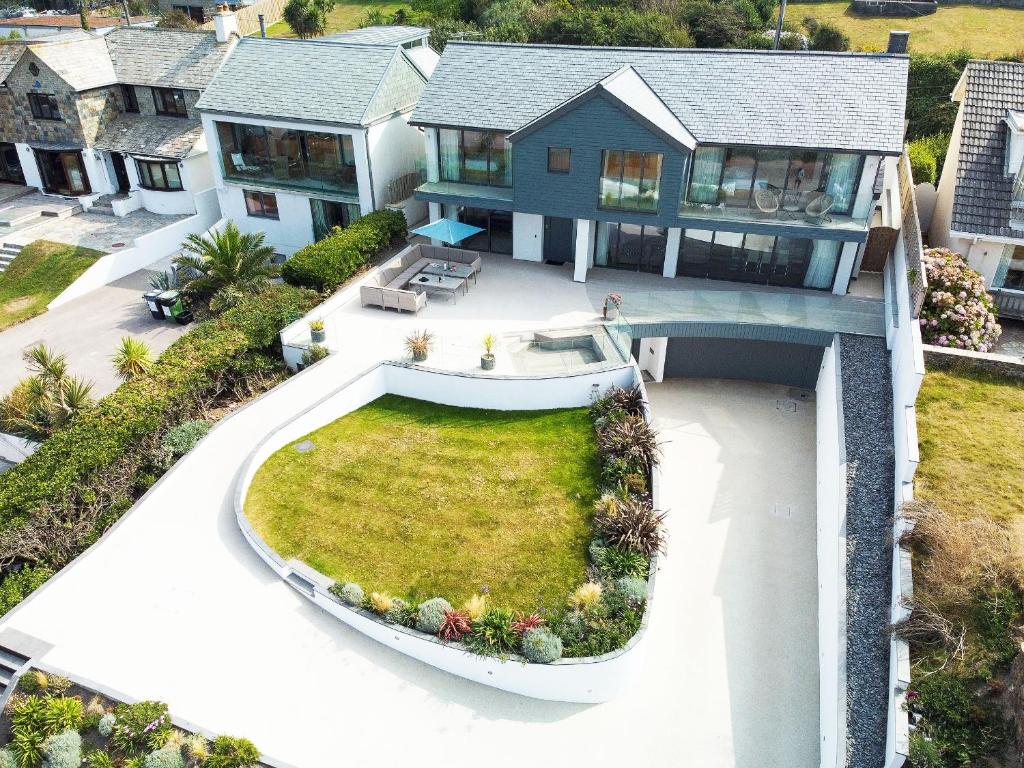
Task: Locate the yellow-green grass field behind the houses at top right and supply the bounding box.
[785,0,1024,57]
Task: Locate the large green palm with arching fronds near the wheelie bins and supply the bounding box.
[174,221,278,311]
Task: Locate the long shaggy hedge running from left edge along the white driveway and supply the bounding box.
[0,286,318,548]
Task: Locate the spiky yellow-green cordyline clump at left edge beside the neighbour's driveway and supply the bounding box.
[0,344,93,441]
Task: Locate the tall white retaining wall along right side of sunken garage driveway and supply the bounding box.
[815,334,846,768]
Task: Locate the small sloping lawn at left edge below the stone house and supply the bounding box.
[0,240,103,330]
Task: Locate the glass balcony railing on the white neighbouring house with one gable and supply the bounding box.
[220,153,359,201]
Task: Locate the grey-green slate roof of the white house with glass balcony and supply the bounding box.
[199,38,426,126]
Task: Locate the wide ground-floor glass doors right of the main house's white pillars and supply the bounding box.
[676,229,843,290]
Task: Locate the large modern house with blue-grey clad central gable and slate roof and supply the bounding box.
[413,42,907,294]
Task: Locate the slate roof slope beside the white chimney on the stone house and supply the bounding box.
[103,28,235,90]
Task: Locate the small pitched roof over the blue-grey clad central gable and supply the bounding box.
[509,65,696,150]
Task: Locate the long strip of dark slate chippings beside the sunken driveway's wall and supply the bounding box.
[839,334,895,768]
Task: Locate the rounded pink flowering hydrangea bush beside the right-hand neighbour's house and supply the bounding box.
[920,248,1002,352]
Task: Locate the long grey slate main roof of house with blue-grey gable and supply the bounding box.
[413,42,908,155]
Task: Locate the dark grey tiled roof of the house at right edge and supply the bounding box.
[950,61,1024,238]
